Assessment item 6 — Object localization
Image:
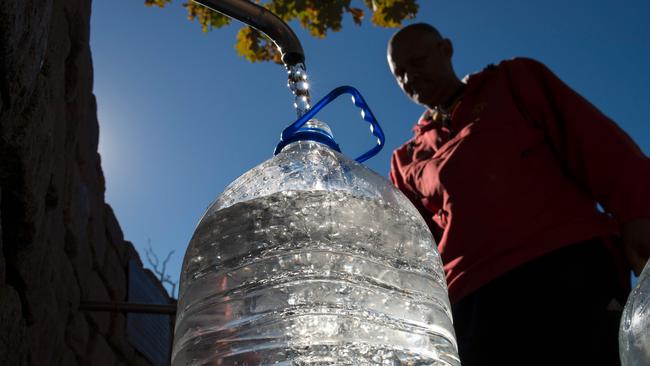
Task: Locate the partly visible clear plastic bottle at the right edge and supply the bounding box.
[618,261,650,366]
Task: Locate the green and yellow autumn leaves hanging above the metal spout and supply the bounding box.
[145,0,418,63]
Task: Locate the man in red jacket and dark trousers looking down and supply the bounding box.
[388,23,650,366]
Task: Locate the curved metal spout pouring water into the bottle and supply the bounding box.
[193,0,305,69]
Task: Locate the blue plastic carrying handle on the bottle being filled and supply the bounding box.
[275,85,386,163]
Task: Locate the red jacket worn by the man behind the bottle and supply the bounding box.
[390,58,650,303]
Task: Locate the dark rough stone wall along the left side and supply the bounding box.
[0,0,171,366]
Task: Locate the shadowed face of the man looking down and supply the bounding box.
[387,32,450,108]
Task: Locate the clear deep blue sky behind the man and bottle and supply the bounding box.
[91,0,650,296]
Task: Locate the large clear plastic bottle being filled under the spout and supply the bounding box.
[172,86,460,366]
